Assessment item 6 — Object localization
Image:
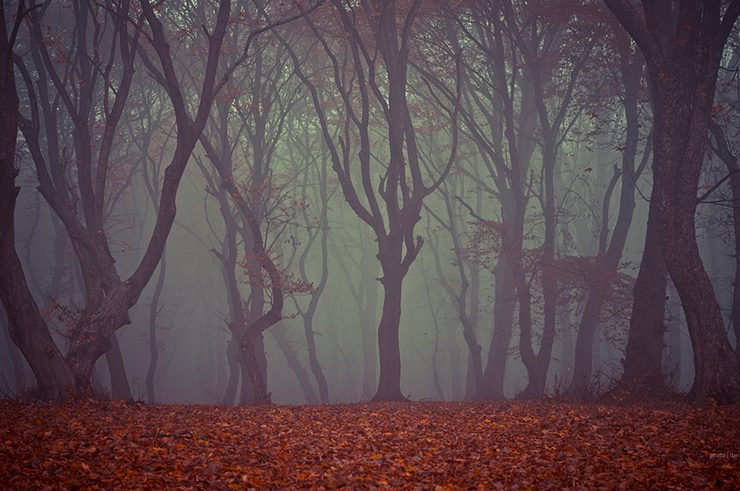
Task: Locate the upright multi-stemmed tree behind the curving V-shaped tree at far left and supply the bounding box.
[16,1,145,399]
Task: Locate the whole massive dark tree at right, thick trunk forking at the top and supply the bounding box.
[605,0,740,401]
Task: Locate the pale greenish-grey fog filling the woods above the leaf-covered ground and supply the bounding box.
[0,1,740,405]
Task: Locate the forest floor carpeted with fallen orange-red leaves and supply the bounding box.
[0,402,740,489]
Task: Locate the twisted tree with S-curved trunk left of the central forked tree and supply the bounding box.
[200,2,324,404]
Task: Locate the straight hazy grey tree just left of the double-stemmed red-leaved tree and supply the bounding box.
[450,1,537,400]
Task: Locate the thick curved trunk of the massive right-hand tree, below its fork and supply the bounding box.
[653,89,740,402]
